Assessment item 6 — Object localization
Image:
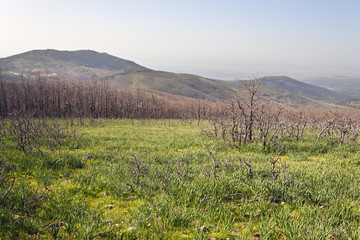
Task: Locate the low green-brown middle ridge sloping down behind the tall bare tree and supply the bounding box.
[101,71,324,107]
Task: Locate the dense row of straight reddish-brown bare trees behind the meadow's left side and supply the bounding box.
[0,73,222,122]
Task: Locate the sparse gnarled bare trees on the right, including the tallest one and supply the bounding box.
[204,78,360,149]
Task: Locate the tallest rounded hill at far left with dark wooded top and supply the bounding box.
[0,49,150,80]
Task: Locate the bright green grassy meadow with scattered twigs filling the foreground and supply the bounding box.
[0,120,360,239]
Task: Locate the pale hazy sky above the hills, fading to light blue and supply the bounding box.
[0,0,360,79]
